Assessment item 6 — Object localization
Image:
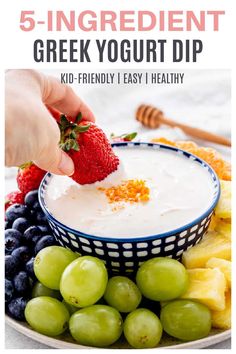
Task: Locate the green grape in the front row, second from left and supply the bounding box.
[69,305,123,347]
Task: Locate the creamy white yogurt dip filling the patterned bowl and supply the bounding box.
[45,147,216,238]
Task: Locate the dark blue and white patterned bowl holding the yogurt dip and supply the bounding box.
[39,142,220,273]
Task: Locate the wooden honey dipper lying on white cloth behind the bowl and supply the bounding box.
[136,105,231,146]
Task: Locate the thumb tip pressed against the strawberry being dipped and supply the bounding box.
[34,146,74,176]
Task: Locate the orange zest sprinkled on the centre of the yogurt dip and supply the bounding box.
[98,179,150,203]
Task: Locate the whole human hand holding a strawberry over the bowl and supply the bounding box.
[5,70,94,176]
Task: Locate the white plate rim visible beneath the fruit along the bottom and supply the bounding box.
[6,316,231,349]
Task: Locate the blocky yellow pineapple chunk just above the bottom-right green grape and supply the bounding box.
[181,268,226,311]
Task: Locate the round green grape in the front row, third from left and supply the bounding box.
[124,308,162,349]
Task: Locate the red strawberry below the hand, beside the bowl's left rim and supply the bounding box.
[16,162,46,194]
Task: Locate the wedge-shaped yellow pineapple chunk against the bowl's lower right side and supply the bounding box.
[182,231,231,268]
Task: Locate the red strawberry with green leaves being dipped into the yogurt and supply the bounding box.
[59,114,119,184]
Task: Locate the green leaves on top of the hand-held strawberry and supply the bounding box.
[58,113,90,152]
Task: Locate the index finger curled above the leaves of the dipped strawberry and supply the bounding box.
[41,75,95,122]
